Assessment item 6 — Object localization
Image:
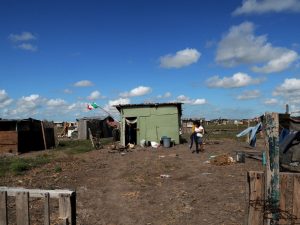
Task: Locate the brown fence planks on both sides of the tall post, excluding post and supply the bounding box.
[247,171,300,225]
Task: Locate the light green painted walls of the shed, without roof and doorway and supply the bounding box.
[121,105,181,144]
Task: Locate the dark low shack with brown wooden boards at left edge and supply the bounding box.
[0,118,55,154]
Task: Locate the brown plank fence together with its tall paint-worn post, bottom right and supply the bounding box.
[247,113,300,225]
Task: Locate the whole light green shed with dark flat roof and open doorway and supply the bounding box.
[115,103,182,145]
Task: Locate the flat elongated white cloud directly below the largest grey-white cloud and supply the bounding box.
[206,73,263,88]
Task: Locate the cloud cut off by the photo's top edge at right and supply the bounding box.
[233,0,300,15]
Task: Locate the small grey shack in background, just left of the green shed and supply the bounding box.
[77,116,114,140]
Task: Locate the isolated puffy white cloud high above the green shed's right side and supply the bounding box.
[160,48,201,68]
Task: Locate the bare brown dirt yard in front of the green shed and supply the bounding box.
[0,139,263,225]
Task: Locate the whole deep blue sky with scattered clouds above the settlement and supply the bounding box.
[0,0,300,121]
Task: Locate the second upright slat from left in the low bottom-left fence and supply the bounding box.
[16,192,30,225]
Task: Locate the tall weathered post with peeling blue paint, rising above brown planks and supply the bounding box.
[263,113,280,225]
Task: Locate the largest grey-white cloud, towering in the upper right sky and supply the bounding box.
[216,22,298,73]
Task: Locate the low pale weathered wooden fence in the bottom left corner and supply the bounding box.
[0,187,76,225]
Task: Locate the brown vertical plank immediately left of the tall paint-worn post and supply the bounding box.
[247,171,264,225]
